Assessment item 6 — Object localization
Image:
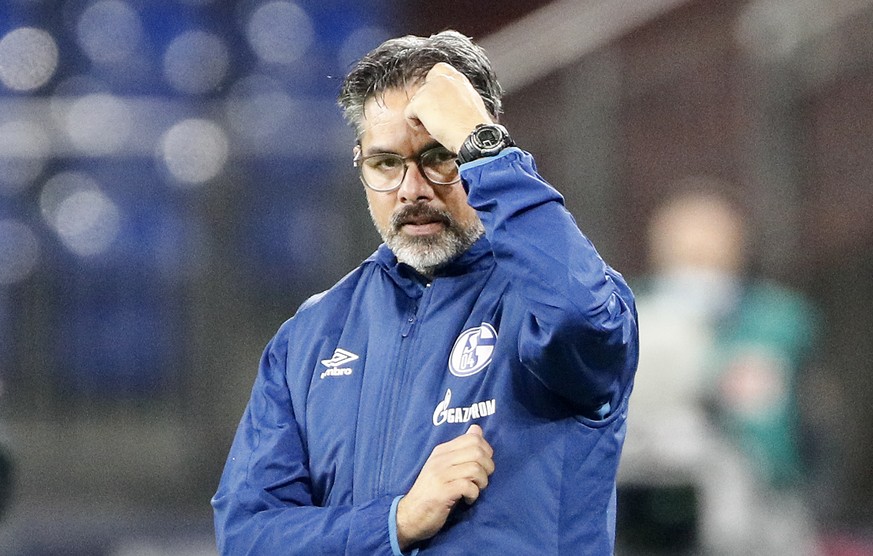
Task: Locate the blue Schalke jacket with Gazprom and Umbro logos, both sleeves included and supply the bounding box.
[212,148,637,556]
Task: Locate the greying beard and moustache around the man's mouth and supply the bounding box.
[370,203,485,276]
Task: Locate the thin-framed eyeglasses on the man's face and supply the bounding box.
[354,146,461,193]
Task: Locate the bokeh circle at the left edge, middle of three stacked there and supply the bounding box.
[0,120,50,195]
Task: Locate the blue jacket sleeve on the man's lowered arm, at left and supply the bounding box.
[212,332,393,556]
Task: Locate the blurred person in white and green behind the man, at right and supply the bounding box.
[617,182,818,556]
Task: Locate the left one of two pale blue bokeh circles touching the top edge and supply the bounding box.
[76,0,143,63]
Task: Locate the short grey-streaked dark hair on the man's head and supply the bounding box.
[337,30,503,136]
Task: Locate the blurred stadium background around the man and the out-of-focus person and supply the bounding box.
[0,0,873,556]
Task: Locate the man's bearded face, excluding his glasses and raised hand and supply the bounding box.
[360,86,483,274]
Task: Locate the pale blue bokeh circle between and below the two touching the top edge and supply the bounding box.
[164,31,230,94]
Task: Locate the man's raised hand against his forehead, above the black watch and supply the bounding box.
[405,62,494,152]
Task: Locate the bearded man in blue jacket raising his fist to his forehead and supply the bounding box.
[213,31,637,555]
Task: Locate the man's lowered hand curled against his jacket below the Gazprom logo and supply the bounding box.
[397,425,494,550]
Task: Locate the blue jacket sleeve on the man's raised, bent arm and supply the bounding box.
[461,148,638,417]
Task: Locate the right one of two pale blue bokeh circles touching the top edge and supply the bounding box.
[246,2,315,64]
